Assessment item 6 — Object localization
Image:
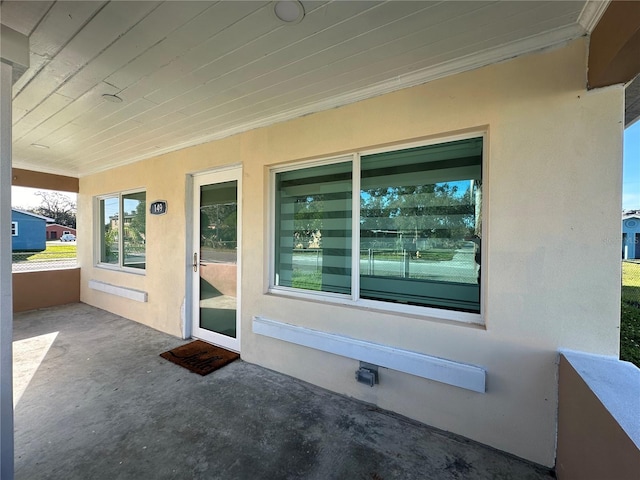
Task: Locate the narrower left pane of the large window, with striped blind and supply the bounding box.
[274,162,352,295]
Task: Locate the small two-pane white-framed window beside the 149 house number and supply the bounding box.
[98,192,146,270]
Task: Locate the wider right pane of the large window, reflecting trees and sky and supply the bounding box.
[360,138,482,312]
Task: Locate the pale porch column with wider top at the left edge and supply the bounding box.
[0,25,29,480]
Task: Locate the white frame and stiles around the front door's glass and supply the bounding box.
[188,163,243,353]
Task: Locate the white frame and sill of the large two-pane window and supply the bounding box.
[267,129,489,326]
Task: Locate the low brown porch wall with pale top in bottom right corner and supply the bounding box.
[556,353,640,480]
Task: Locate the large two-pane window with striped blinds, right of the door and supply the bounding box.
[272,137,483,314]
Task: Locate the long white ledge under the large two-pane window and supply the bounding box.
[253,317,486,393]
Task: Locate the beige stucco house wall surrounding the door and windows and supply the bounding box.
[78,40,623,465]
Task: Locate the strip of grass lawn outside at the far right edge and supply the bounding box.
[620,262,640,368]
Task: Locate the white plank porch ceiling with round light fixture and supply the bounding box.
[0,0,606,177]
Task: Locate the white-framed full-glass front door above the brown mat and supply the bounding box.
[192,168,242,352]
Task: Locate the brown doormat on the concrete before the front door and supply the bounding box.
[160,340,240,375]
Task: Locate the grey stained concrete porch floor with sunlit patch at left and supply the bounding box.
[14,304,554,480]
